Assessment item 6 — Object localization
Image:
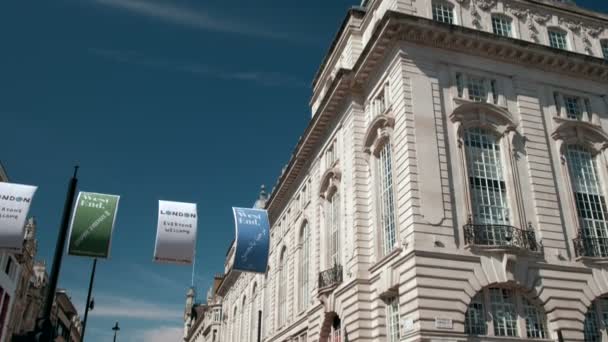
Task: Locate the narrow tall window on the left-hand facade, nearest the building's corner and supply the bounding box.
[376,142,397,255]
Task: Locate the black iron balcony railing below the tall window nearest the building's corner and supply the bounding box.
[464,223,540,252]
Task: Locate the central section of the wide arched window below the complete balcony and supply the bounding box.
[490,288,517,336]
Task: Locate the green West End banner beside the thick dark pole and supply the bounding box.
[68,192,120,258]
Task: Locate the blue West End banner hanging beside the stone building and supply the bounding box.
[232,208,270,273]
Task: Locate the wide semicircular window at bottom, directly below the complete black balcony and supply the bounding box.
[464,287,548,339]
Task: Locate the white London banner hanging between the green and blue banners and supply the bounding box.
[154,201,198,265]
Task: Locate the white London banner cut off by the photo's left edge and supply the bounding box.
[0,183,38,253]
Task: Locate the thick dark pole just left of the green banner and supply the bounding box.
[36,166,78,342]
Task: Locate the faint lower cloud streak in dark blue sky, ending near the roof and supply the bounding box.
[88,48,307,88]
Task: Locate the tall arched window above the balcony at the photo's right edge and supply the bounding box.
[566,145,608,257]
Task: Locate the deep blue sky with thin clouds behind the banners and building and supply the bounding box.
[0,0,608,342]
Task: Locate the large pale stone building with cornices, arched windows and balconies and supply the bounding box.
[185,0,608,342]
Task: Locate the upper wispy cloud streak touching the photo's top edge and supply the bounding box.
[91,0,290,40]
